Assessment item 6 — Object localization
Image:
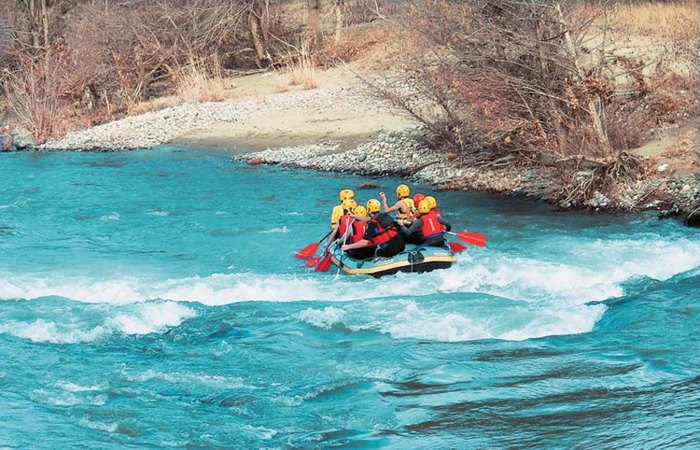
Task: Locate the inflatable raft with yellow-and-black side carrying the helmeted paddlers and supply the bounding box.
[329,243,457,278]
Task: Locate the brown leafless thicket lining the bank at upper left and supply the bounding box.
[0,0,382,143]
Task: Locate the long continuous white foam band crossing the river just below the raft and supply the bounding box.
[0,236,700,305]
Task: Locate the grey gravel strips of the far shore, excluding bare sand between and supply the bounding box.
[40,77,700,222]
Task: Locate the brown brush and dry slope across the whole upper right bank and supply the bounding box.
[375,0,698,205]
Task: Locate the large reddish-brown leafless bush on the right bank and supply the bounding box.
[374,0,628,162]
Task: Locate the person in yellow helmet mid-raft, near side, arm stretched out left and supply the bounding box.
[341,198,406,258]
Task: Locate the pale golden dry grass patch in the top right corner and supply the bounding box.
[615,0,700,39]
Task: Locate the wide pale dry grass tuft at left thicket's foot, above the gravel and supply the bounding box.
[175,58,226,102]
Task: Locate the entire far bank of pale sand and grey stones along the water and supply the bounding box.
[19,67,700,223]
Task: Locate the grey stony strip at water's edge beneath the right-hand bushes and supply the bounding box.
[237,128,700,221]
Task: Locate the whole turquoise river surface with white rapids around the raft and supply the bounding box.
[0,148,700,449]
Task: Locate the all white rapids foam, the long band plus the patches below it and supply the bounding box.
[0,239,700,343]
